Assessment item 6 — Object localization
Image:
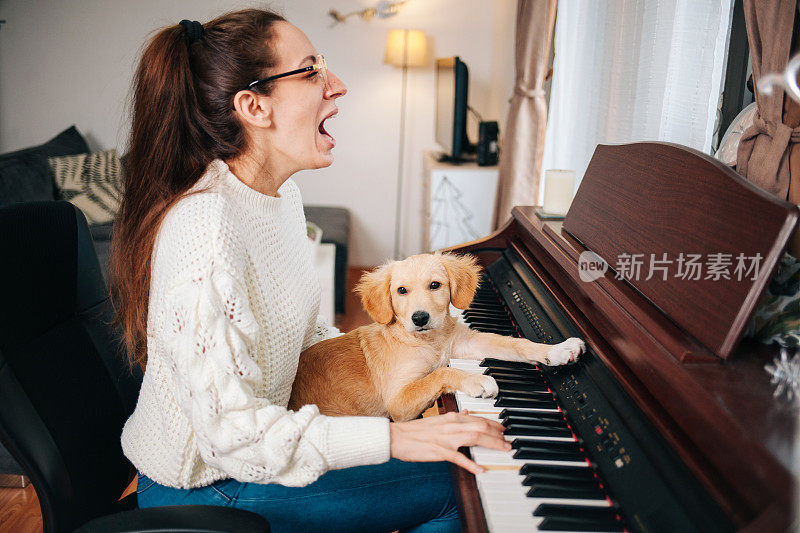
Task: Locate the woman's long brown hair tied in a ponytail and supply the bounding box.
[109,9,284,369]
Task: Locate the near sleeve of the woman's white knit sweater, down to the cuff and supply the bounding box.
[164,261,389,486]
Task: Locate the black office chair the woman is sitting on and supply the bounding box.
[0,201,269,532]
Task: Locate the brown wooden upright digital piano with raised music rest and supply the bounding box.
[439,143,798,533]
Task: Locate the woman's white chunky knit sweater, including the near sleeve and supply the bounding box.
[122,160,389,488]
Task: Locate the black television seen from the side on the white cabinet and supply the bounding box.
[436,56,472,161]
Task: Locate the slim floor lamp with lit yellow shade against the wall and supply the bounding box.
[383,30,428,259]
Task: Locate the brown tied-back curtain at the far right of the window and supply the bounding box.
[736,0,800,199]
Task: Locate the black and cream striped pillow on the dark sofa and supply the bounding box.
[47,150,123,224]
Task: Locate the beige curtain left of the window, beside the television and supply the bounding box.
[494,0,556,228]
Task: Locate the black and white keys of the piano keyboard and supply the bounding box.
[450,279,625,533]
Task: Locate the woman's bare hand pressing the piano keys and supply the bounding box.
[389,411,511,474]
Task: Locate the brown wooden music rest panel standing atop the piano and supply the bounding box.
[563,143,798,358]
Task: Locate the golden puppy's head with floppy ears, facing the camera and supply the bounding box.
[356,253,480,333]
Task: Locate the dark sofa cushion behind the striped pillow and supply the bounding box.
[0,126,89,207]
